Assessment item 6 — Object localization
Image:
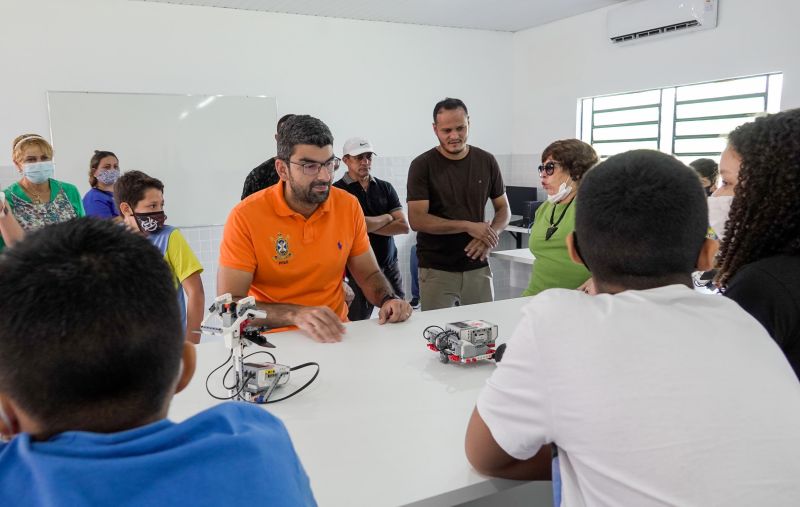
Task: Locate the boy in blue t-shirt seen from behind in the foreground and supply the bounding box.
[0,218,315,507]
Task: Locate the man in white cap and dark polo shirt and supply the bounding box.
[334,137,409,320]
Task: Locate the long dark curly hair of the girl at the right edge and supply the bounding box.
[716,109,800,289]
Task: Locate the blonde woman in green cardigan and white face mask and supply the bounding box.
[0,134,84,249]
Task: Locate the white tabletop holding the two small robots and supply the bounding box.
[169,298,540,506]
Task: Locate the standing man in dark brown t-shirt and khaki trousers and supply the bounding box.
[407,98,509,310]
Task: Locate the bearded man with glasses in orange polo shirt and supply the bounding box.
[217,115,411,342]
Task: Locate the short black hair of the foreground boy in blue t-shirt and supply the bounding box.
[0,218,184,432]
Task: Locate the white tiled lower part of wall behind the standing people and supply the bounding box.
[181,155,539,307]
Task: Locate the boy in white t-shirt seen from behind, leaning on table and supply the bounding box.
[466,150,800,507]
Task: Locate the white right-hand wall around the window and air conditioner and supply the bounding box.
[512,0,800,159]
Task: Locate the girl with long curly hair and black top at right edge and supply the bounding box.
[717,109,800,377]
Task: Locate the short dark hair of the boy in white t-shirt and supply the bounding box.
[575,150,708,289]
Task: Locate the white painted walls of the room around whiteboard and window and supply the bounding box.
[0,0,800,302]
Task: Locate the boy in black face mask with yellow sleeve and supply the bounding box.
[114,171,205,343]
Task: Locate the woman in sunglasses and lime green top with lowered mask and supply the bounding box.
[522,139,598,296]
